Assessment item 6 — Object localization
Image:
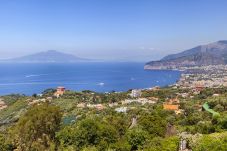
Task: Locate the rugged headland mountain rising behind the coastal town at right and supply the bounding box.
[144,40,227,69]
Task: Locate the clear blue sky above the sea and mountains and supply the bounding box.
[0,0,227,62]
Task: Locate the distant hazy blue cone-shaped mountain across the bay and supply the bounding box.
[1,50,91,63]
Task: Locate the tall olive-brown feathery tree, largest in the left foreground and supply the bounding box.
[11,103,62,151]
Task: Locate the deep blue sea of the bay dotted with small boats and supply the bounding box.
[0,63,180,95]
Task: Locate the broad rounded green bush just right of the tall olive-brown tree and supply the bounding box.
[57,118,118,150]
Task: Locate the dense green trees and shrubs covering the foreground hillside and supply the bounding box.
[0,88,227,151]
